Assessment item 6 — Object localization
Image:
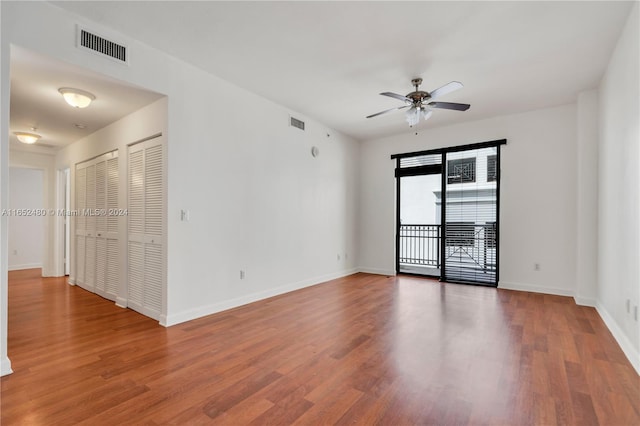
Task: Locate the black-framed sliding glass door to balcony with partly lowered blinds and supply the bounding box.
[392,140,506,286]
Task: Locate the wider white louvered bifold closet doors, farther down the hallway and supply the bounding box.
[71,151,122,300]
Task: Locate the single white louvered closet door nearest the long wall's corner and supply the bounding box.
[127,137,164,319]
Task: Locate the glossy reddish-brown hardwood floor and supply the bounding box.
[1,270,640,426]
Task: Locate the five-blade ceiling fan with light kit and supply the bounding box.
[367,78,471,126]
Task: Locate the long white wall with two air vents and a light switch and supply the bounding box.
[0,2,359,371]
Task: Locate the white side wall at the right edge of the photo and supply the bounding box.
[596,4,640,373]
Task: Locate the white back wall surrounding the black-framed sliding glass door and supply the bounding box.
[359,105,577,295]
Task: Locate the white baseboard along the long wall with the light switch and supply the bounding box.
[160,268,359,327]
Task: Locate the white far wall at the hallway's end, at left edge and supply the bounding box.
[9,167,47,271]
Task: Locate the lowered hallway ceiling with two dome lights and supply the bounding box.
[9,46,162,152]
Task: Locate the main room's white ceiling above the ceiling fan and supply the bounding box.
[12,1,633,150]
